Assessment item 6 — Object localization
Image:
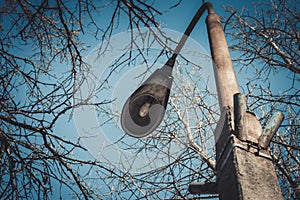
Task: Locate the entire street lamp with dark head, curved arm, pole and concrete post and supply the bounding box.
[121,2,283,200]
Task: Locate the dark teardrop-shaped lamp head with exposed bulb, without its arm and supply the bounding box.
[121,66,173,137]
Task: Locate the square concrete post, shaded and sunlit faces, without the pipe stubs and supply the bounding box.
[216,108,283,200]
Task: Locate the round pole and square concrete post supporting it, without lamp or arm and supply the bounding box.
[189,2,283,200]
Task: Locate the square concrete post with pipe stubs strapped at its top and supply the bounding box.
[216,94,283,200]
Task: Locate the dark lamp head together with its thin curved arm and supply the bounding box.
[121,2,233,137]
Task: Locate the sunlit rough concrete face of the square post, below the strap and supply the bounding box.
[233,145,282,200]
